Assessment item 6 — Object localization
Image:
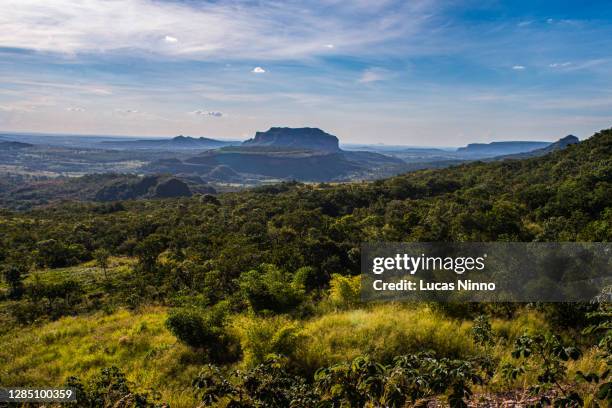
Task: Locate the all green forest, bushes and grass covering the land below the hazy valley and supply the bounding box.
[0,129,612,407]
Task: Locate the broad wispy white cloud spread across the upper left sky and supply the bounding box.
[0,0,439,60]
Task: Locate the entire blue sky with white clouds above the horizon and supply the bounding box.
[0,0,612,146]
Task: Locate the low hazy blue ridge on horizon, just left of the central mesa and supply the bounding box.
[100,135,236,150]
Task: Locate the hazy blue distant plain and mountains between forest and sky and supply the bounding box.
[0,127,578,186]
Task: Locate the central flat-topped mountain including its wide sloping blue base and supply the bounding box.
[147,127,406,183]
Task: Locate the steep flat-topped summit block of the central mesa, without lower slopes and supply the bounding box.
[242,127,340,152]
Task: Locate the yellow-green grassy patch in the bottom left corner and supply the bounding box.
[0,308,201,407]
